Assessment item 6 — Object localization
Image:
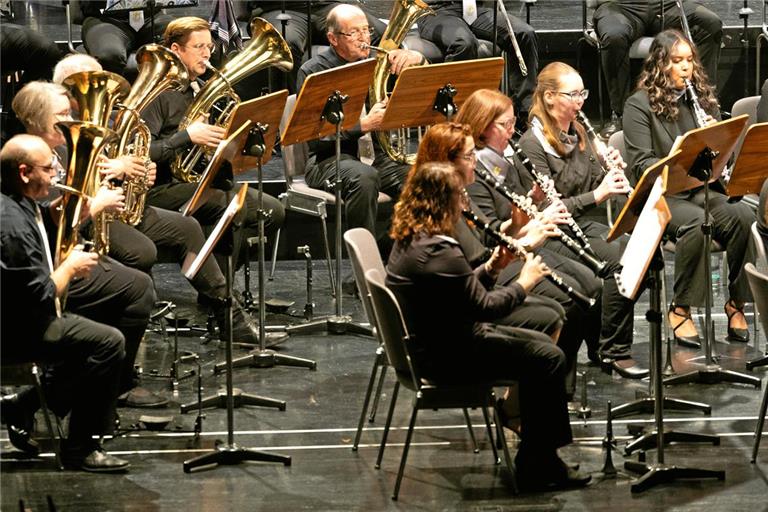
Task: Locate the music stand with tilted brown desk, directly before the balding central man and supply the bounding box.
[281,59,376,336]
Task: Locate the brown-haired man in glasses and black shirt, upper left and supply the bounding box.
[142,17,285,268]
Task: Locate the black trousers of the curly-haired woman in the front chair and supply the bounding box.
[438,323,573,454]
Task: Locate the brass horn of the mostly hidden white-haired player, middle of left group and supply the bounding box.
[107,44,189,226]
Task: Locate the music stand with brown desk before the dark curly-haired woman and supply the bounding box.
[664,114,761,388]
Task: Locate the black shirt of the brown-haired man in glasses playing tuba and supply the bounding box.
[141,80,195,185]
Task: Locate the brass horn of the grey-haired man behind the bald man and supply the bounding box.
[63,71,130,254]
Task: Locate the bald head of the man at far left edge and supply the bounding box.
[0,134,53,199]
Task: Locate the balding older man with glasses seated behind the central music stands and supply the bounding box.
[296,4,426,246]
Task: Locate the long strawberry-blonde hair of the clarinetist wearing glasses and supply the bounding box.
[528,62,586,156]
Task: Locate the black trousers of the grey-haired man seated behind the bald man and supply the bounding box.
[66,256,155,393]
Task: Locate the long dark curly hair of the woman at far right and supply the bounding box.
[637,29,720,121]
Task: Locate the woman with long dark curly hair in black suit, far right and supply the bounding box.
[624,30,755,347]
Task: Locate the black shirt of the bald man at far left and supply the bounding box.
[0,193,56,343]
